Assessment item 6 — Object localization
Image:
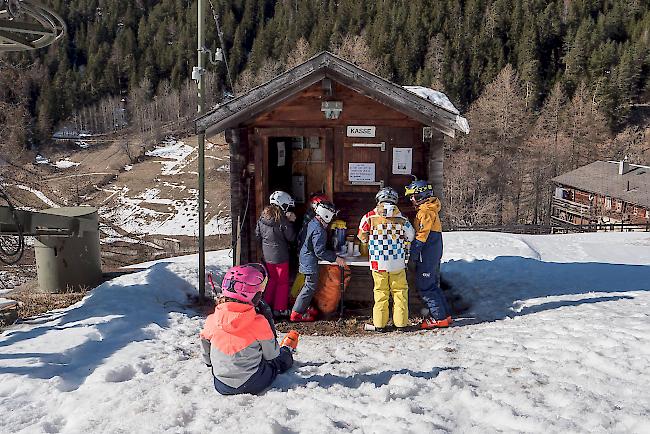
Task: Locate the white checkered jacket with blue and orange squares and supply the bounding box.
[357,203,415,272]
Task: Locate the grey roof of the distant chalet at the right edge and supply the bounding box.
[553,161,650,209]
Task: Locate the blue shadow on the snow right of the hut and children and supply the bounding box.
[442,256,650,324]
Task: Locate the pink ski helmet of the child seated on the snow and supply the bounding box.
[221,264,269,304]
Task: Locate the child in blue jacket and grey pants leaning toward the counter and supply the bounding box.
[289,201,345,322]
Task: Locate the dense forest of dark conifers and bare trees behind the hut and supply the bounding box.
[0,0,650,225]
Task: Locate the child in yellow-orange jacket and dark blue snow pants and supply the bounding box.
[406,181,451,328]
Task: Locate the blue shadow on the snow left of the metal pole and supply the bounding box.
[0,264,196,391]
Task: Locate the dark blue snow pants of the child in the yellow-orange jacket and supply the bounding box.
[415,231,451,320]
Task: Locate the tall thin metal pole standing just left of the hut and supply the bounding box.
[197,0,205,302]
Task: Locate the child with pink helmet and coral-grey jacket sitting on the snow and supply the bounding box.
[200,264,293,395]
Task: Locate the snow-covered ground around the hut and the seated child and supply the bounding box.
[0,233,650,434]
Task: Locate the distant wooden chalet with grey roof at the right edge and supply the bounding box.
[551,160,650,229]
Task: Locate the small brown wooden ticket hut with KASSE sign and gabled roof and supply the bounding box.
[196,52,469,300]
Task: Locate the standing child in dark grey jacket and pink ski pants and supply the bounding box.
[255,191,296,316]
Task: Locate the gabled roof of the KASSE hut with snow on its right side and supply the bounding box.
[196,51,469,137]
